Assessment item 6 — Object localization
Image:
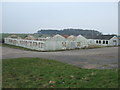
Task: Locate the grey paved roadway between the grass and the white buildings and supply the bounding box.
[0,47,118,69]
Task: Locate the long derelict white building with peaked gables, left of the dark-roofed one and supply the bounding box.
[4,34,88,51]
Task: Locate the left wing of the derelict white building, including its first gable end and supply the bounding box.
[4,35,66,51]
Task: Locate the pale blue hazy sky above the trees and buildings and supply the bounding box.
[2,2,118,34]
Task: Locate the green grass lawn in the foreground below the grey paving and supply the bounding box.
[2,58,118,88]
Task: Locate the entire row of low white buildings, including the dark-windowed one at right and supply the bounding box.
[4,34,118,51]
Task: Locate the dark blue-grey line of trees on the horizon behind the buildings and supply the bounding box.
[37,29,102,37]
